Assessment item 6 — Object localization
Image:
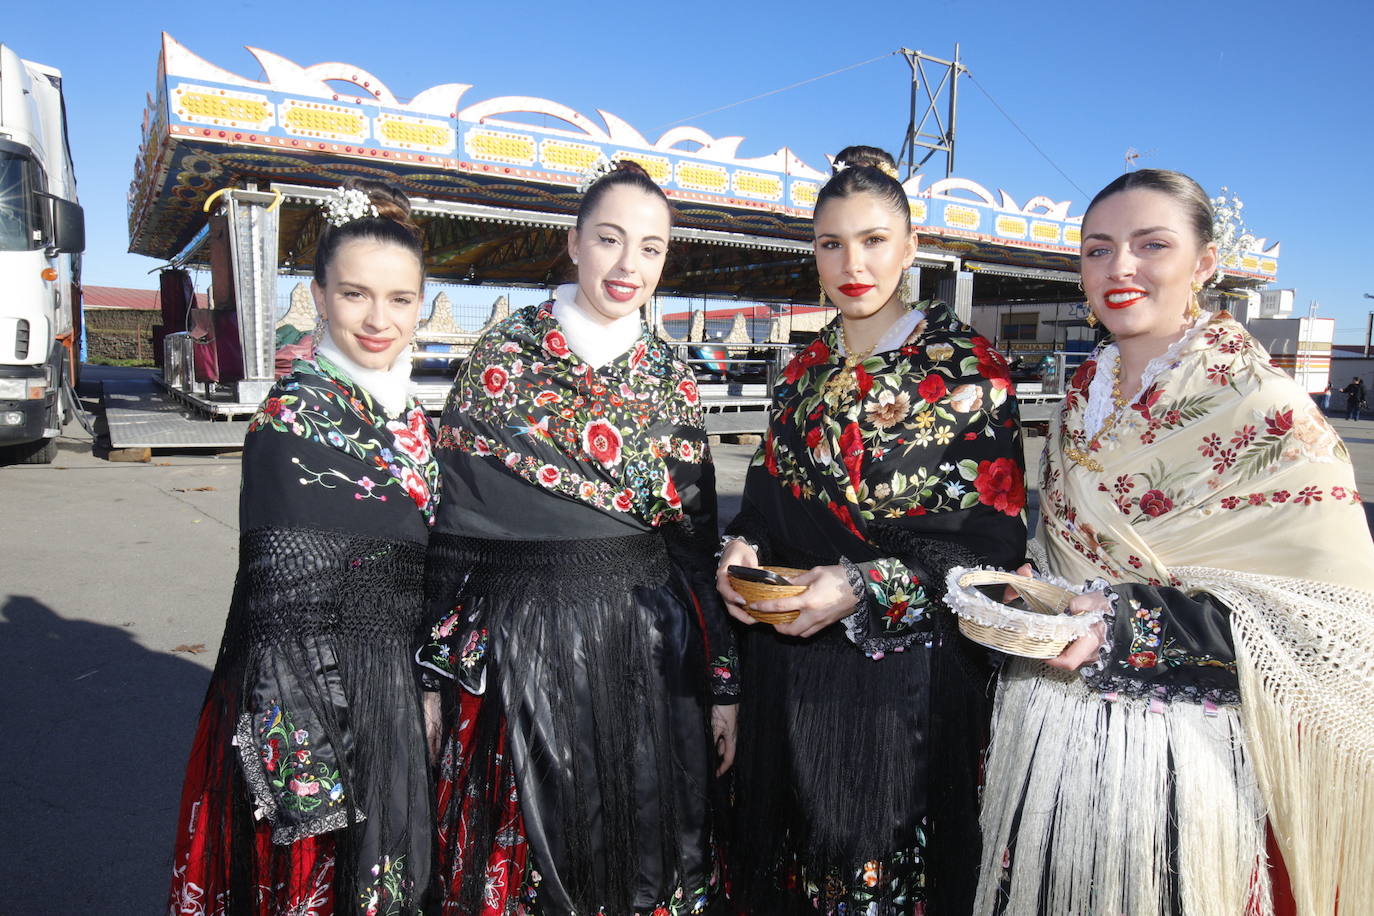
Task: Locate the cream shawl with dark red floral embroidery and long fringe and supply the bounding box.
[1039,313,1374,915]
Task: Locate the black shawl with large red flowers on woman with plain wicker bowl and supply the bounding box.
[731,304,1026,655]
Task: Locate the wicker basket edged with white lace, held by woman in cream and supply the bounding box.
[948,570,1076,658]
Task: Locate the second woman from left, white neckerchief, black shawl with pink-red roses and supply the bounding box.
[420,162,738,916]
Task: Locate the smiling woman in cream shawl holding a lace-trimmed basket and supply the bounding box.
[977,169,1374,916]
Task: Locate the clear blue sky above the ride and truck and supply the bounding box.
[0,0,1374,342]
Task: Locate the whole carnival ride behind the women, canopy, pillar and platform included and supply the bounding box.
[112,34,1278,450]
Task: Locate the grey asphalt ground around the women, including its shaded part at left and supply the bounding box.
[8,376,1374,916]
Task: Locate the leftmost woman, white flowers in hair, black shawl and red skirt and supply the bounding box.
[170,179,438,916]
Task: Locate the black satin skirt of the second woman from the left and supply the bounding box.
[430,533,719,916]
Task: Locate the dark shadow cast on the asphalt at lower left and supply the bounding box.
[0,596,209,916]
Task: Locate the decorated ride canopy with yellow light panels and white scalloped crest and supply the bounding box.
[129,34,1278,301]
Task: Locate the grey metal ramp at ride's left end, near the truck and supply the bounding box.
[102,374,249,449]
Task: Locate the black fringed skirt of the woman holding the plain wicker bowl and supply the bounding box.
[728,555,989,916]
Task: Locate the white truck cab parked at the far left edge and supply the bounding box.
[0,44,85,464]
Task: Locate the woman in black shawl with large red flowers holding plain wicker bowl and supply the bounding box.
[717,147,1025,916]
